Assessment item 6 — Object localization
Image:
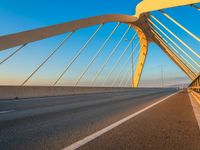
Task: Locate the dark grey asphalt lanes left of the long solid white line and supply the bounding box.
[0,89,176,150]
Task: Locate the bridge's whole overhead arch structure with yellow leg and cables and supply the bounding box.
[0,0,200,88]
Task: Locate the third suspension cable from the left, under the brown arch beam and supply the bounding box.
[53,24,104,86]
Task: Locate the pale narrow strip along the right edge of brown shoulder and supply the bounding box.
[189,94,200,130]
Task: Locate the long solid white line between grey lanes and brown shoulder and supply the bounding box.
[62,92,178,150]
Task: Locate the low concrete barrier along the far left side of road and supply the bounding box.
[0,86,132,100]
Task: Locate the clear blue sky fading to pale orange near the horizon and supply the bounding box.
[0,0,200,86]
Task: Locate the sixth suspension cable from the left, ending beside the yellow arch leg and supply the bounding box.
[103,33,137,85]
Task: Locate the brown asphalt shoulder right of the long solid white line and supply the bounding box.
[80,91,200,150]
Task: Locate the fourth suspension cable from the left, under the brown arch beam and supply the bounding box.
[75,22,120,86]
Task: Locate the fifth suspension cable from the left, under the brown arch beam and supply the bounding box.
[91,25,131,85]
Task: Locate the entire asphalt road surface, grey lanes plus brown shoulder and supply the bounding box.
[0,89,200,150]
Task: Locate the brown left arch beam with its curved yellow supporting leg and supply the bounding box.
[0,14,194,87]
